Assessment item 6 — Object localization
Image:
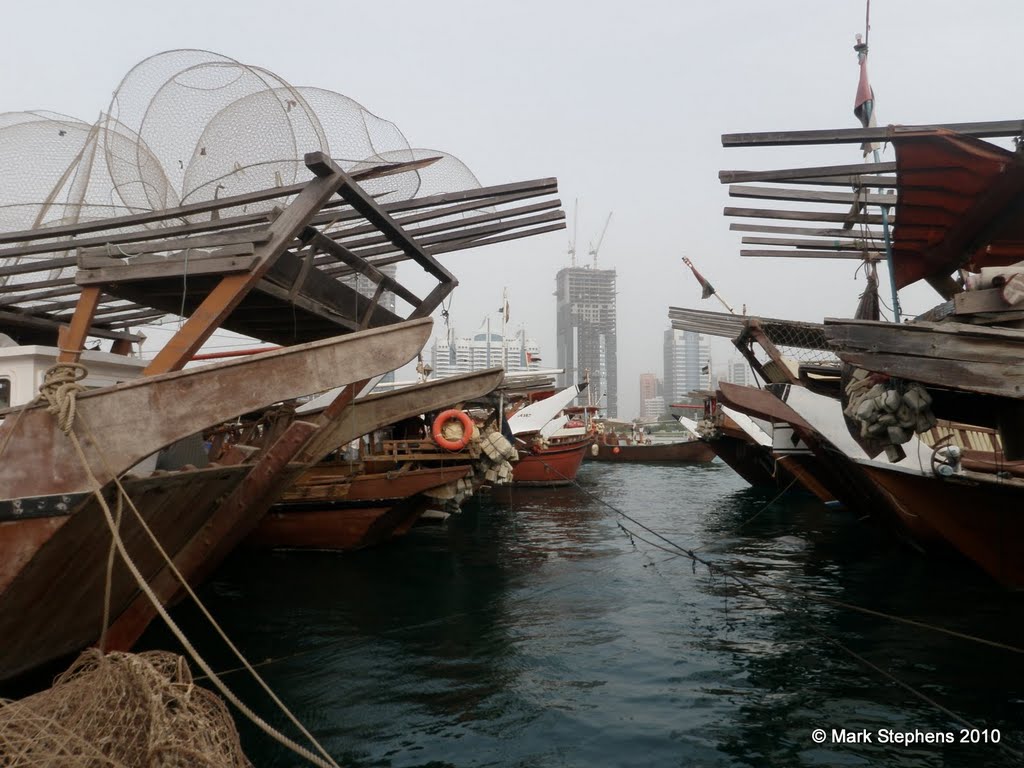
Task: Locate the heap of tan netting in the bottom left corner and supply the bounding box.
[0,649,251,768]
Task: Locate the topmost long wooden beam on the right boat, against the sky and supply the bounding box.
[722,120,1024,146]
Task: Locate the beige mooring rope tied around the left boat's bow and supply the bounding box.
[40,364,339,768]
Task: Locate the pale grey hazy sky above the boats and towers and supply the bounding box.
[0,0,1024,417]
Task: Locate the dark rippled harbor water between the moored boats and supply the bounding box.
[146,463,1024,767]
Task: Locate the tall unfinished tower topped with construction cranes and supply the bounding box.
[555,266,618,417]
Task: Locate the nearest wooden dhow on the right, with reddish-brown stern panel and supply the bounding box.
[679,114,1024,588]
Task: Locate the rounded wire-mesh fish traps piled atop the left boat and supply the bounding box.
[0,50,480,309]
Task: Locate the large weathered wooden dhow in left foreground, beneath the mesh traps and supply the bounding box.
[0,145,563,681]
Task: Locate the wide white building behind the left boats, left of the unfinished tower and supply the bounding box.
[430,322,541,378]
